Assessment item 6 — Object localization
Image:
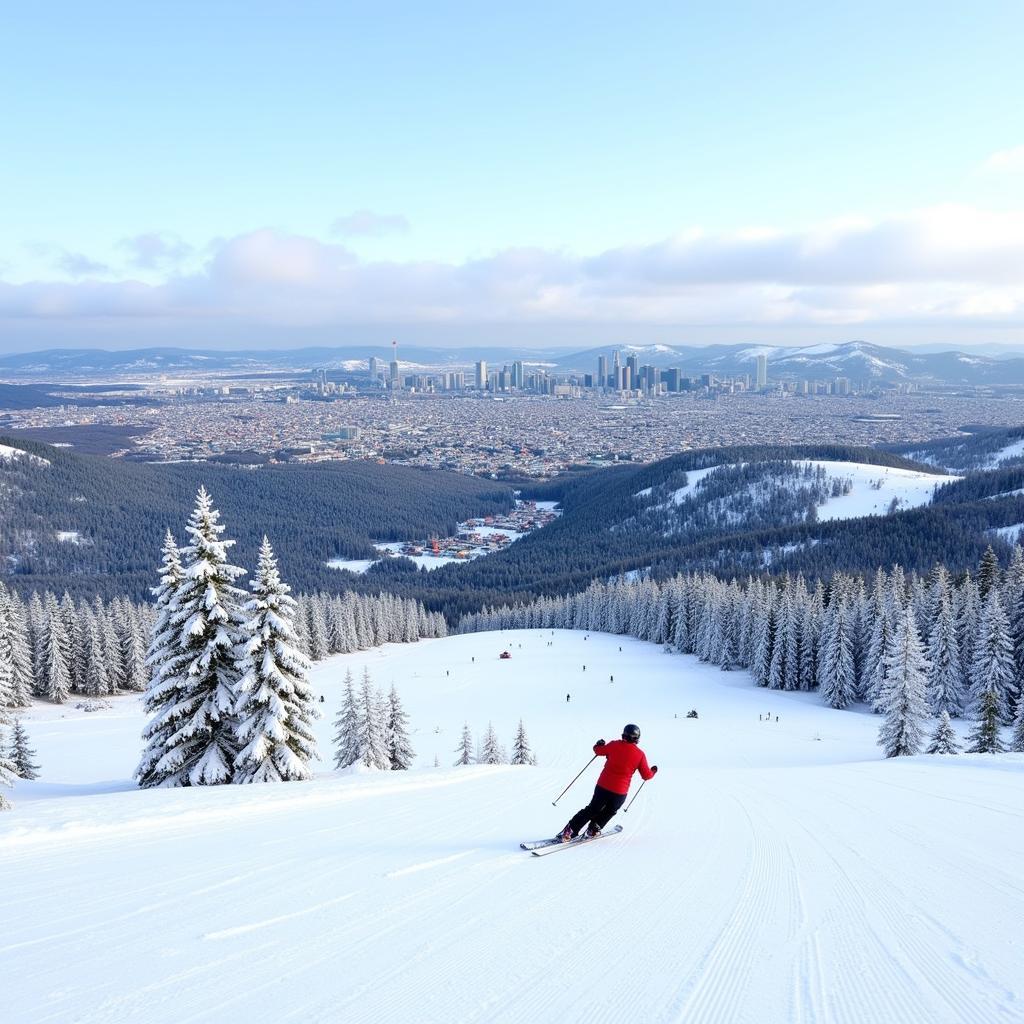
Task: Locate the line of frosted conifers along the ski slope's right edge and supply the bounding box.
[459,545,1024,756]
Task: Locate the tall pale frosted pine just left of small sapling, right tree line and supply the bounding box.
[879,604,928,758]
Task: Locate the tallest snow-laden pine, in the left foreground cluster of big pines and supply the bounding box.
[138,487,246,785]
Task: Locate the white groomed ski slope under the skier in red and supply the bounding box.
[6,631,1024,1024]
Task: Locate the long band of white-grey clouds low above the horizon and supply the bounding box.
[6,206,1024,342]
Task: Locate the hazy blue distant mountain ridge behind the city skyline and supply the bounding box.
[0,341,1024,385]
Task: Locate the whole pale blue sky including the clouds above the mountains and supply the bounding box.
[0,0,1024,352]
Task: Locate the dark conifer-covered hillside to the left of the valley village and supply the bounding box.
[0,436,513,600]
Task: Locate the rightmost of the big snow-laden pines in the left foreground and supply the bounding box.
[234,537,317,783]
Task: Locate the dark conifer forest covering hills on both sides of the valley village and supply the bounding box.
[0,438,1024,623]
